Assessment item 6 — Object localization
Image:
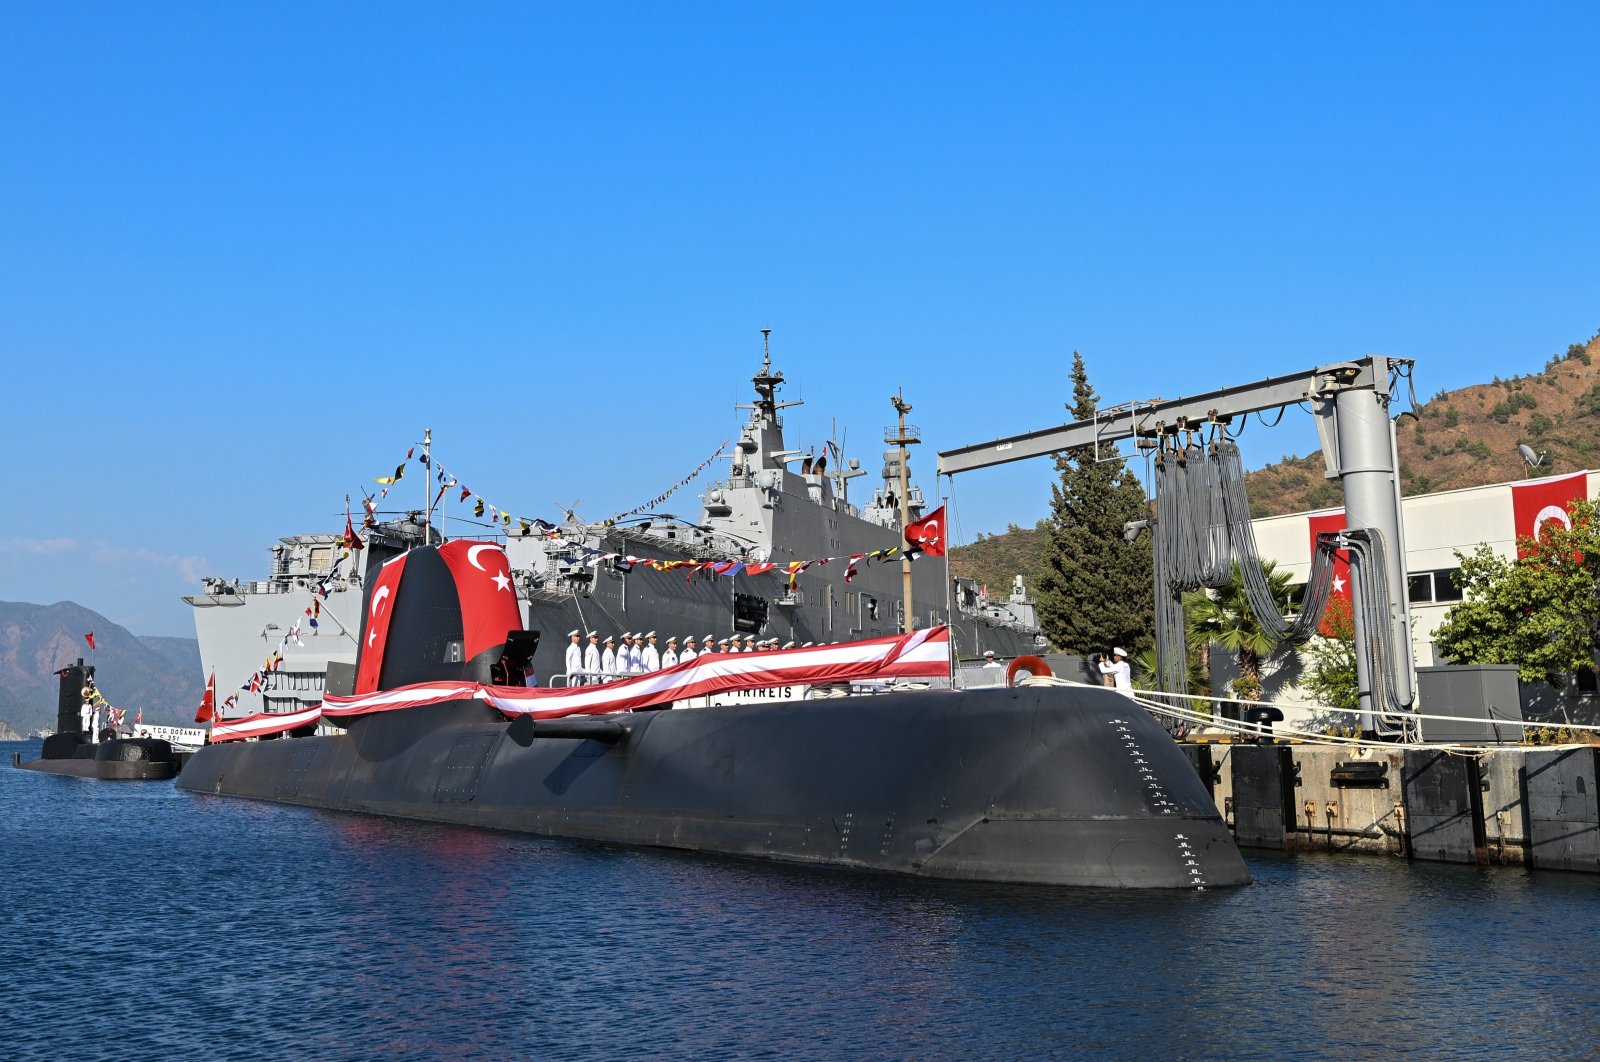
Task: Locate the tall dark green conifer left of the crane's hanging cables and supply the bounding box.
[1038,350,1155,656]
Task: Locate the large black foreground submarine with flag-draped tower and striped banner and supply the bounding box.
[178,541,1250,889]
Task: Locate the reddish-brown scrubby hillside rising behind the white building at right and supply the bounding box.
[1246,336,1600,517]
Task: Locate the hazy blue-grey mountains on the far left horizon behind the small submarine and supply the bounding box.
[0,601,205,733]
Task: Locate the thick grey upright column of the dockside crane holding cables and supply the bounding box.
[1334,358,1411,731]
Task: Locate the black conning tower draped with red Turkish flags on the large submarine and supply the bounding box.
[355,539,539,693]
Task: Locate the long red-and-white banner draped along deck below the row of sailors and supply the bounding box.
[323,627,950,718]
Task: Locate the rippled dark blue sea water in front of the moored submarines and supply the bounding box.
[0,742,1600,1060]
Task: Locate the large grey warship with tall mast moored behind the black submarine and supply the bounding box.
[184,349,1046,717]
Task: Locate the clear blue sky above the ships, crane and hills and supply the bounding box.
[0,3,1600,635]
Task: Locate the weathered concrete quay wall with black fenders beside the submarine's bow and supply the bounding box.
[1181,741,1600,873]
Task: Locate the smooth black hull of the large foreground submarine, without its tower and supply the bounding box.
[178,686,1250,889]
